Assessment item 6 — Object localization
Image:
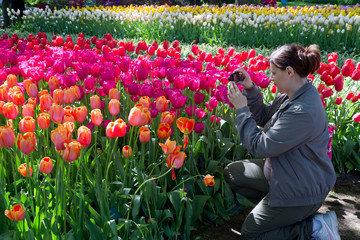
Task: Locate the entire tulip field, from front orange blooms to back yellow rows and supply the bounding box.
[0,1,360,239]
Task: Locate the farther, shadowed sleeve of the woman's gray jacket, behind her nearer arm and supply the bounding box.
[243,84,284,127]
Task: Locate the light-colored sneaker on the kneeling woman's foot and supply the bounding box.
[312,211,341,240]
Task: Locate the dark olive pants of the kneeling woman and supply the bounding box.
[224,159,322,240]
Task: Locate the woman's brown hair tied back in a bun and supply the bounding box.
[269,43,321,77]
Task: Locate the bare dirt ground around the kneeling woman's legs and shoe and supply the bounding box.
[191,171,360,240]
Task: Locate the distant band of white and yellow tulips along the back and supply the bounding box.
[8,5,360,49]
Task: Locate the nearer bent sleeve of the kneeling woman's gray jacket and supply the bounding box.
[235,104,315,157]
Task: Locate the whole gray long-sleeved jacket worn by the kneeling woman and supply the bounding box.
[235,82,336,207]
